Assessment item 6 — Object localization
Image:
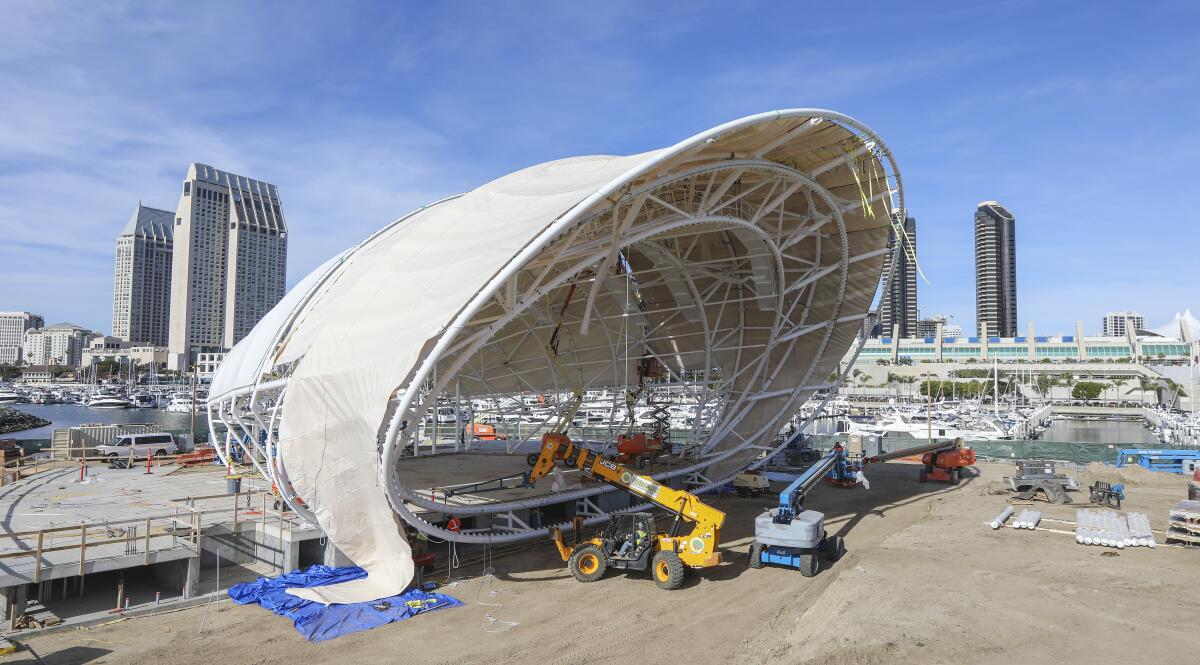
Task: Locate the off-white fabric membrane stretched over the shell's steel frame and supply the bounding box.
[214,112,898,603]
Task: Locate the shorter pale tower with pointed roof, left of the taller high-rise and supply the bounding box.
[113,203,175,347]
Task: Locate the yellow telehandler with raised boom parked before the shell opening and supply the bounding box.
[526,432,725,591]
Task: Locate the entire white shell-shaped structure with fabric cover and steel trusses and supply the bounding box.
[208,109,904,603]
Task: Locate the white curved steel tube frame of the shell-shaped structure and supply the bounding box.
[208,109,904,543]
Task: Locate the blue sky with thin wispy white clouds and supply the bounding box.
[0,0,1200,333]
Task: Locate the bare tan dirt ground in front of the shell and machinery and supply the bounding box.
[7,463,1200,665]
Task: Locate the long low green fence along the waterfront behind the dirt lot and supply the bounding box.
[812,435,1200,465]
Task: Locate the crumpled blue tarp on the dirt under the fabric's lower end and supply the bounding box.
[229,564,462,642]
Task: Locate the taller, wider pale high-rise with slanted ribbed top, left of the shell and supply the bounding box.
[168,163,288,369]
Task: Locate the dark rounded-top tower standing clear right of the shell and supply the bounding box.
[974,200,1016,337]
